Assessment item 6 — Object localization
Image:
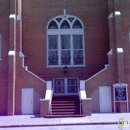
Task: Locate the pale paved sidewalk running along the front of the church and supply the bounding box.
[0,113,130,127]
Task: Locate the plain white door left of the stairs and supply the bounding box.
[22,88,33,114]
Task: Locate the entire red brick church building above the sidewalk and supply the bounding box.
[0,0,130,117]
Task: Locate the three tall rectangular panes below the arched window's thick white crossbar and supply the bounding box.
[47,34,84,66]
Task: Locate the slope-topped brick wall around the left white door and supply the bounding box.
[15,57,46,114]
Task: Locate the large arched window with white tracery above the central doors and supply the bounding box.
[47,15,85,67]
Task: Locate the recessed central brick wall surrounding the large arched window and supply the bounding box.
[23,0,109,80]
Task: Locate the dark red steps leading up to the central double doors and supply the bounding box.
[46,96,82,117]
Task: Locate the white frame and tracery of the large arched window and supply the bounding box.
[46,15,86,67]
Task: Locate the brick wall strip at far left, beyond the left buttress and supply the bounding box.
[0,0,9,115]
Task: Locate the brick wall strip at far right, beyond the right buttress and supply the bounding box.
[120,0,130,108]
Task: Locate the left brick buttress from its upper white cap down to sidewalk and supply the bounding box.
[8,14,16,115]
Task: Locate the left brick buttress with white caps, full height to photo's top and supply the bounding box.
[7,0,17,115]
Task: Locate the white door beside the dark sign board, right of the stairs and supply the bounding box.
[99,86,112,113]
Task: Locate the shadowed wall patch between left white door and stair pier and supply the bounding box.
[33,91,41,114]
